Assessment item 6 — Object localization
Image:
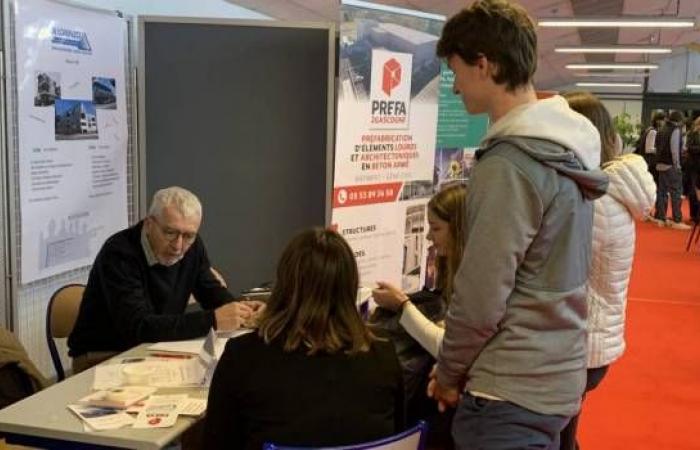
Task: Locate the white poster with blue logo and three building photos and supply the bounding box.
[15,0,129,283]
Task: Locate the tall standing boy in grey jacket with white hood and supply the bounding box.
[428,0,607,450]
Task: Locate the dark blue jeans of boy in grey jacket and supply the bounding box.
[452,392,569,450]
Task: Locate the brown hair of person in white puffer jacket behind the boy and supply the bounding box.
[563,91,620,165]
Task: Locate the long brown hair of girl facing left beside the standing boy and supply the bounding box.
[428,184,467,301]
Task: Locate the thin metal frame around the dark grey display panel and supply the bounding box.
[135,16,336,225]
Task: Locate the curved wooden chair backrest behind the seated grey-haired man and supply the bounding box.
[46,284,85,381]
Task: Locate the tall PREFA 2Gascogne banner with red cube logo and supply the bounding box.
[332,0,444,292]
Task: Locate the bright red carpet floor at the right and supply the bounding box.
[579,216,700,450]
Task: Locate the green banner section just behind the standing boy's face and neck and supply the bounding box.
[437,63,489,148]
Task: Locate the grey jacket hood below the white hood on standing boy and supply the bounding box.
[476,136,608,200]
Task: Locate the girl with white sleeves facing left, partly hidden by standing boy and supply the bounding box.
[370,185,467,450]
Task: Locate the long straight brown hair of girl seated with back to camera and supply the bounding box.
[258,228,375,355]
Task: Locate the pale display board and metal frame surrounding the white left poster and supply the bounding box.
[0,0,139,373]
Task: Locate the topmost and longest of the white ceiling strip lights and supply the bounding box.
[537,16,695,28]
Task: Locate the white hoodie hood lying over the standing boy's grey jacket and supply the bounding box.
[481,95,600,169]
